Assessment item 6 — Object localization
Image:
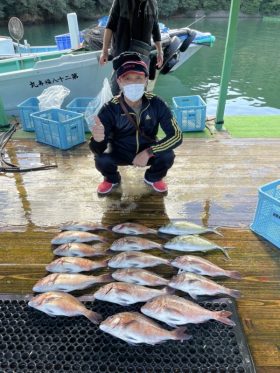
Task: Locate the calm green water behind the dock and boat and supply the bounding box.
[0,19,280,115]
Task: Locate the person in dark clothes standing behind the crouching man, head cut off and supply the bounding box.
[99,0,163,95]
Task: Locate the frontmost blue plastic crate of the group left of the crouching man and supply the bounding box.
[31,109,85,150]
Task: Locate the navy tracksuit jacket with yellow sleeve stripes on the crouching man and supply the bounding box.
[89,92,183,161]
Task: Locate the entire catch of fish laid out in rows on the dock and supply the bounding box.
[28,221,241,345]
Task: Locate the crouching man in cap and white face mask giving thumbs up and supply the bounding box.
[89,52,182,195]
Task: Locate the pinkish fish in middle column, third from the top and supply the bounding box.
[108,251,170,268]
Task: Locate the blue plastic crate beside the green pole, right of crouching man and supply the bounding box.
[172,96,206,132]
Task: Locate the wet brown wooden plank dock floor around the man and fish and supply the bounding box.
[0,139,280,373]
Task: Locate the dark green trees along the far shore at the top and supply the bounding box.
[0,0,280,22]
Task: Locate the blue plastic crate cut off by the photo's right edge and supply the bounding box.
[251,180,280,248]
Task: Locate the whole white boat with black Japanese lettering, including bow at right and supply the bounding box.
[0,17,215,115]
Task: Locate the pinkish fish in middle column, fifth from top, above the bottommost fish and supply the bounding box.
[93,282,174,306]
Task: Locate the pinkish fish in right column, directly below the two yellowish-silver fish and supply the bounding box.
[171,255,241,280]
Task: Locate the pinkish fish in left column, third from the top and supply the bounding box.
[53,243,108,257]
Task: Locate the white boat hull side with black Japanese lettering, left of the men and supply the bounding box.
[0,52,112,115]
